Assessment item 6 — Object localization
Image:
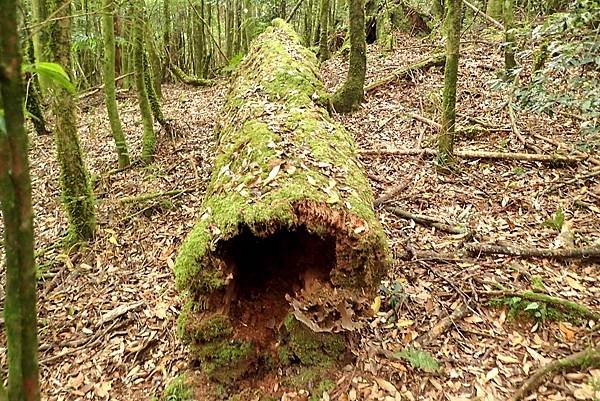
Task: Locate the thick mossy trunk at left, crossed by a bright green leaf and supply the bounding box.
[49,0,96,241]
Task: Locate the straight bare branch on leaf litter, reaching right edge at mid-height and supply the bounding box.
[465,244,600,259]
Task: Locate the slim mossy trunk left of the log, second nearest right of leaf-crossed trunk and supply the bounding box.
[131,0,156,163]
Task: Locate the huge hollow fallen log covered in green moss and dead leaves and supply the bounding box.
[175,20,389,382]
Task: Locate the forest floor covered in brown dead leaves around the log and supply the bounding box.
[0,28,600,401]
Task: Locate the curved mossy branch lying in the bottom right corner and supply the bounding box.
[511,346,600,401]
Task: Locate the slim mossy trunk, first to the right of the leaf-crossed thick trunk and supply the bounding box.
[102,0,130,168]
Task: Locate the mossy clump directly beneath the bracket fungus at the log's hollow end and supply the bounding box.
[278,314,346,366]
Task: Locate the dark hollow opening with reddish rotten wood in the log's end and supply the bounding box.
[216,226,336,350]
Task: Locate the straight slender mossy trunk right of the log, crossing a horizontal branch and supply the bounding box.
[437,0,462,166]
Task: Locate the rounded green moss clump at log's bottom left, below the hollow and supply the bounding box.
[194,340,256,384]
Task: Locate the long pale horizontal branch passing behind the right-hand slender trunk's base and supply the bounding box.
[359,149,585,163]
